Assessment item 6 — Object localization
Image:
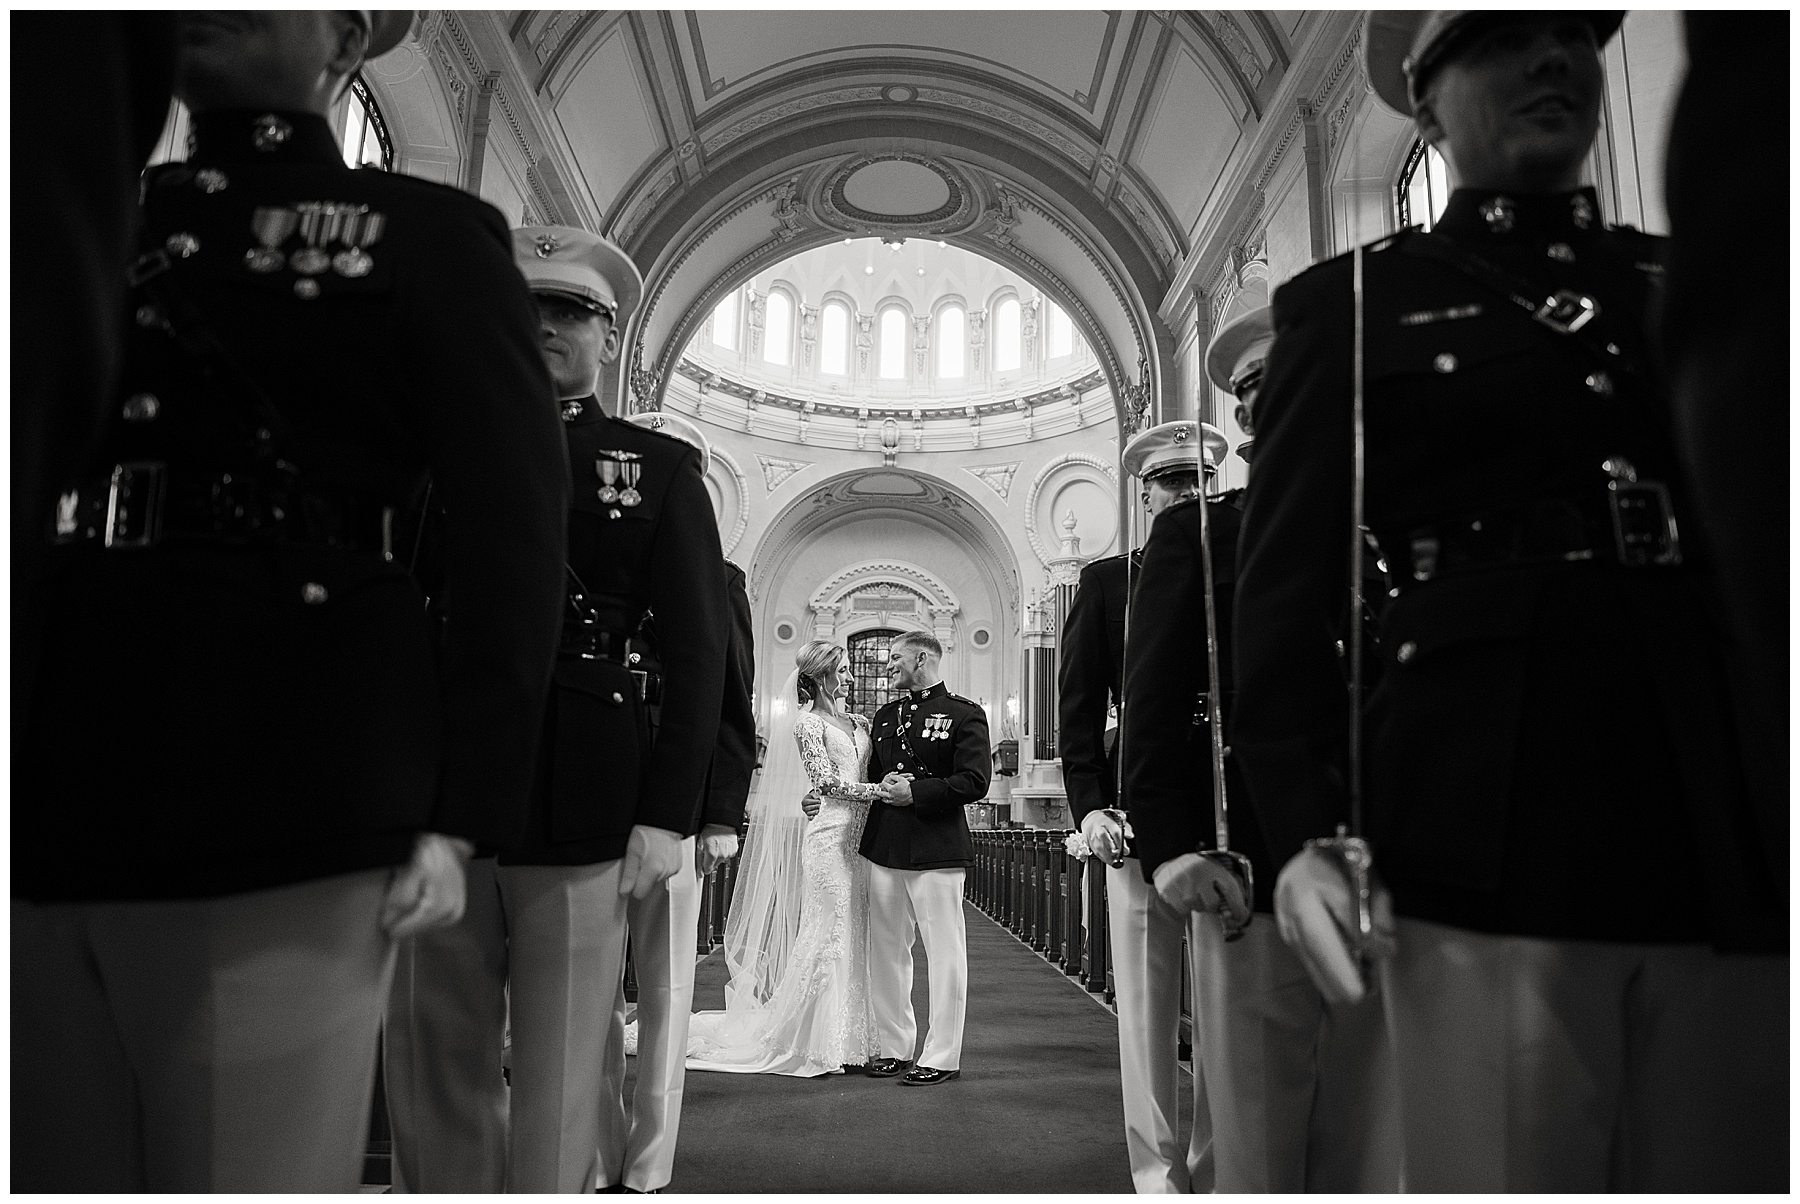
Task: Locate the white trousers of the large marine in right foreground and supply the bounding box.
[1382,920,1789,1193]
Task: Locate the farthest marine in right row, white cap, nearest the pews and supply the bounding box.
[1057,421,1222,1193]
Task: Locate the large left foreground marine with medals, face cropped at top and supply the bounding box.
[13,13,567,1191]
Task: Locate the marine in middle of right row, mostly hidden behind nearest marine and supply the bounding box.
[1130,356,1399,1193]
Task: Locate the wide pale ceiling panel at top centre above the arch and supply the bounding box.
[677,9,1125,124]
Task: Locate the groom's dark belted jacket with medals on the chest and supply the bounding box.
[862,682,990,869]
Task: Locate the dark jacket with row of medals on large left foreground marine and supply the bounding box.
[13,112,569,900]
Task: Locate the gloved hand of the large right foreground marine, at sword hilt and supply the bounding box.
[1274,849,1395,1002]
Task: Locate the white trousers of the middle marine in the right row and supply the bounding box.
[1188,914,1400,1193]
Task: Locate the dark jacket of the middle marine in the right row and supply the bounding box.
[1121,491,1278,899]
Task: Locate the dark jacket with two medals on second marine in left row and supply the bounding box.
[500,398,731,866]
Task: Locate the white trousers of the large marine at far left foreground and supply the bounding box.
[11,869,394,1193]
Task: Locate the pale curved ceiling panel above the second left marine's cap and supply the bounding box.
[556,22,668,209]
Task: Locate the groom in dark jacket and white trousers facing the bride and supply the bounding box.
[862,632,990,1087]
